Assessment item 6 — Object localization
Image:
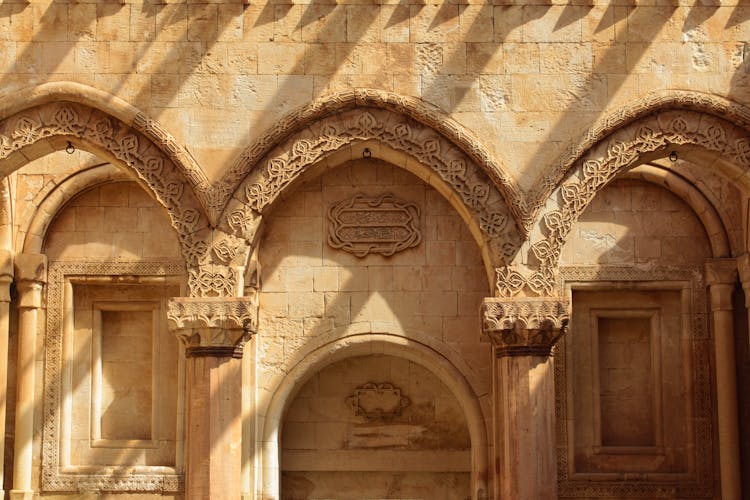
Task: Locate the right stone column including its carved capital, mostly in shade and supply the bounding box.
[482,298,568,500]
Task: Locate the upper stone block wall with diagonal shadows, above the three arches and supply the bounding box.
[0,0,748,187]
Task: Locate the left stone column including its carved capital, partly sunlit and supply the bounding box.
[167,297,258,499]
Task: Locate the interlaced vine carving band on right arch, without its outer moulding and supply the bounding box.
[531,111,750,274]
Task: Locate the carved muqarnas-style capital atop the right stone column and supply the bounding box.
[482,297,569,358]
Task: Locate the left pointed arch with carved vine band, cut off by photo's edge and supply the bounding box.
[0,82,210,267]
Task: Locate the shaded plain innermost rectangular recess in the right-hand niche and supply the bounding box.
[598,317,656,446]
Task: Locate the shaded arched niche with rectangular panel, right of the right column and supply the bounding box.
[555,169,720,498]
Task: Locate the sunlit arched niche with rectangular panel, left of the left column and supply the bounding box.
[37,178,186,493]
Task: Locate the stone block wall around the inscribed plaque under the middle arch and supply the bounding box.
[258,160,490,391]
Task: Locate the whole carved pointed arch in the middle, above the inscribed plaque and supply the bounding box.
[216,90,526,267]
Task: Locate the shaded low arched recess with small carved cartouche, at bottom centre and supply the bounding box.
[281,354,471,498]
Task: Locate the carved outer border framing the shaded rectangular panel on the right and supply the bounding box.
[555,266,714,498]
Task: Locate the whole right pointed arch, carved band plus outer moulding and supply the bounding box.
[530,92,750,269]
